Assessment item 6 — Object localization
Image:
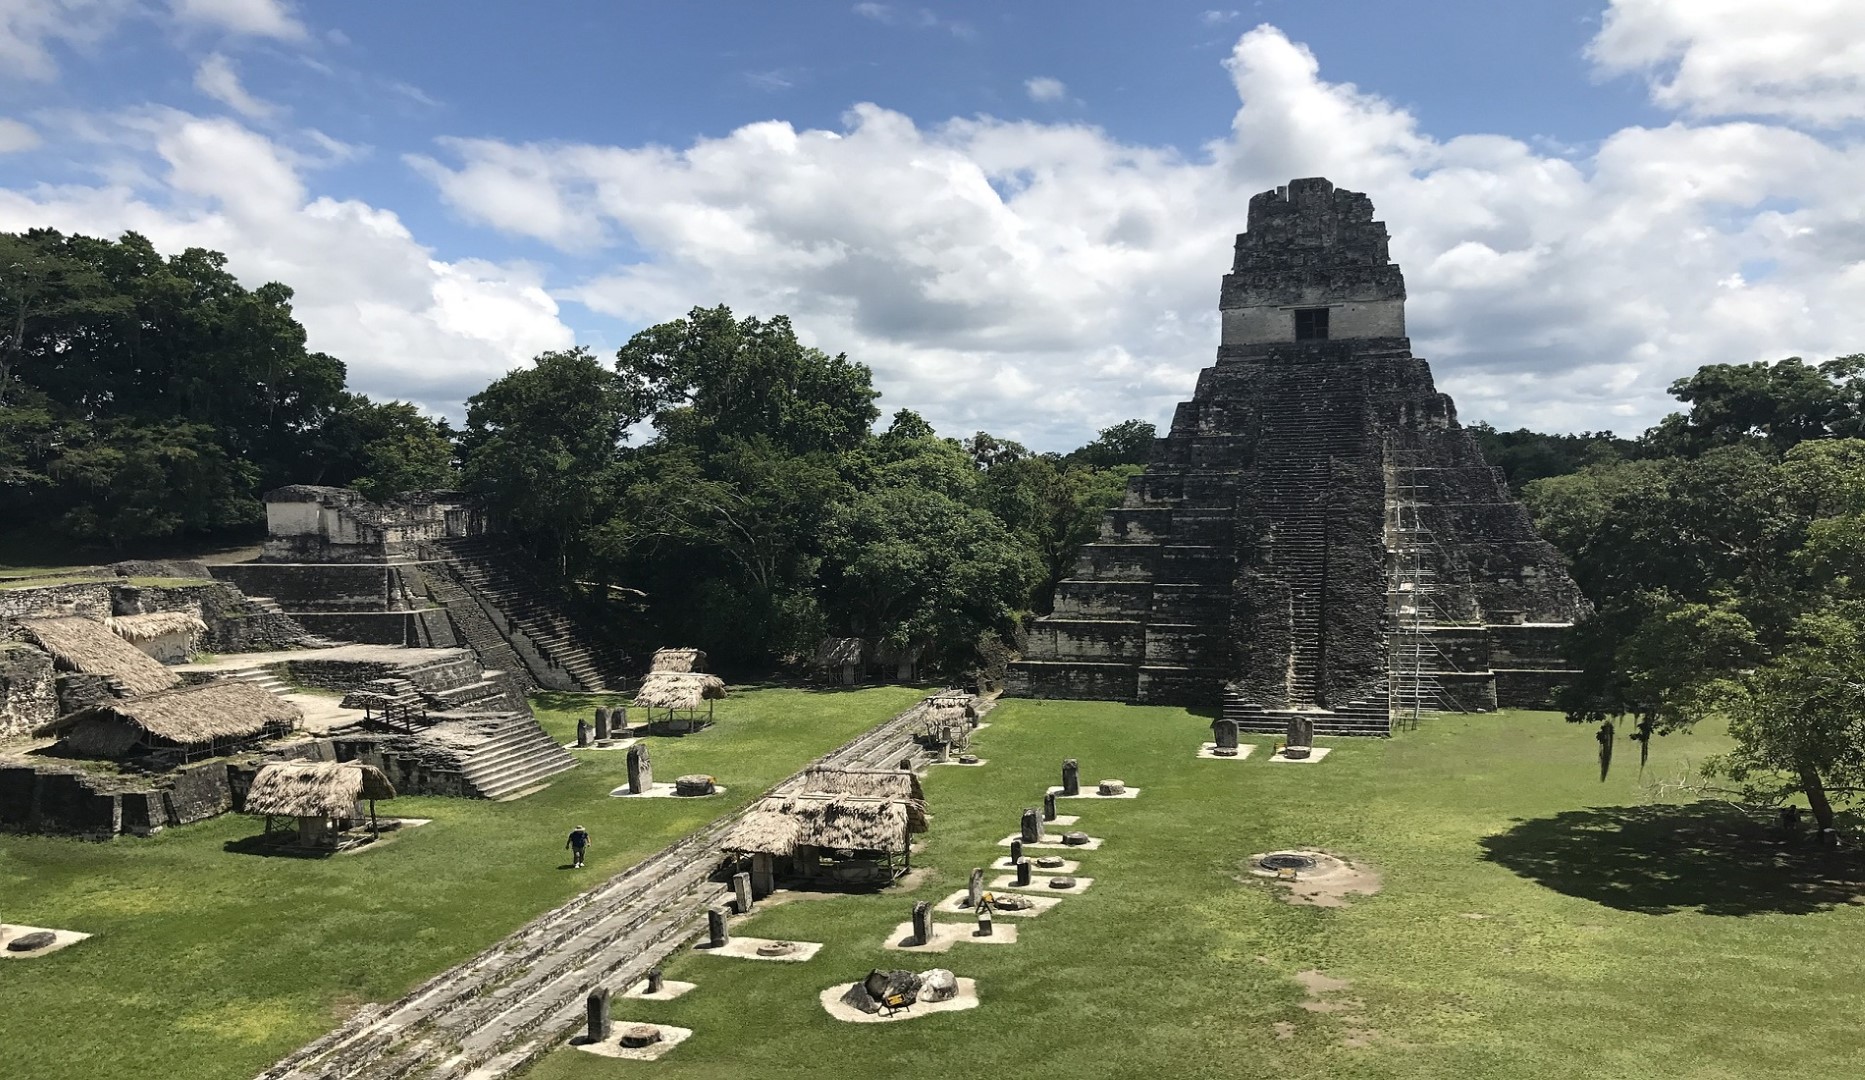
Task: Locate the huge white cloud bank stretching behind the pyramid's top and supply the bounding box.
[414,26,1865,446]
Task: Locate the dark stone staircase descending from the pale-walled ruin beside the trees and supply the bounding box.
[433,535,630,692]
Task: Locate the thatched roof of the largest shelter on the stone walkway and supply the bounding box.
[724,767,929,854]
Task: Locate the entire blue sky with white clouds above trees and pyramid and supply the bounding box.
[0,0,1865,450]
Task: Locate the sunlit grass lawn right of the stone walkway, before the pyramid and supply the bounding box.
[528,701,1865,1080]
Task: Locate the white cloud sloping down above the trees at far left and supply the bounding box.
[0,110,573,416]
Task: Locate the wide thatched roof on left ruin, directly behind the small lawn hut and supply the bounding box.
[39,686,304,754]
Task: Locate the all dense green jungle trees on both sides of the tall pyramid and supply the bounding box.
[0,229,1865,817]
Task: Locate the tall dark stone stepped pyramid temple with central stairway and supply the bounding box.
[1007,177,1587,735]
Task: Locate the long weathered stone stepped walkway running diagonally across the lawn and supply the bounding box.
[259,703,962,1080]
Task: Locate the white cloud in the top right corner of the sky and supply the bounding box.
[1589,0,1865,125]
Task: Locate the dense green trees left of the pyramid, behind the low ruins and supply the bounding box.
[0,229,1154,670]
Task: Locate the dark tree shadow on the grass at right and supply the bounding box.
[1481,802,1865,916]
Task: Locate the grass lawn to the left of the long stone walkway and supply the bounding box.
[0,686,923,1080]
